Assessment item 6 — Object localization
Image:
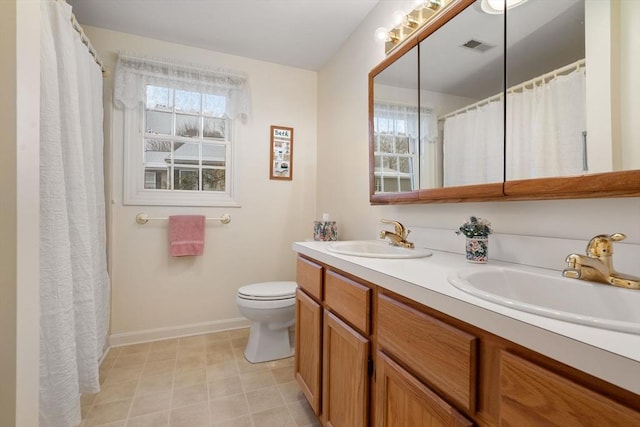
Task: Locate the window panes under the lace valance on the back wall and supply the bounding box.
[143,85,232,193]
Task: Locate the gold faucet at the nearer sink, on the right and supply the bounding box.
[562,233,640,289]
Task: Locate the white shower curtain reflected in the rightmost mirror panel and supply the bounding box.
[506,68,586,180]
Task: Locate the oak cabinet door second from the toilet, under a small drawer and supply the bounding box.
[322,311,370,427]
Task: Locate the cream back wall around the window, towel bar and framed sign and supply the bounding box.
[85,26,317,345]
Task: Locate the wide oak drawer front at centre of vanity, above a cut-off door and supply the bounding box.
[377,295,478,413]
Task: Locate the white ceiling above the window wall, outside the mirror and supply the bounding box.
[67,0,378,71]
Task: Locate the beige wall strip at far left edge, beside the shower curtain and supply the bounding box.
[0,1,40,427]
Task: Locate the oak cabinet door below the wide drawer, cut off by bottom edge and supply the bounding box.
[375,351,473,427]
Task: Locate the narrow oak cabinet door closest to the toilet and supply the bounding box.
[295,288,322,415]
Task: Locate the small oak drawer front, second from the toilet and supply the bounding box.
[324,271,371,336]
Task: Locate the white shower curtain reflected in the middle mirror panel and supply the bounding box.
[444,99,504,187]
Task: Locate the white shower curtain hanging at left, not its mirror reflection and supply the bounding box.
[39,0,109,427]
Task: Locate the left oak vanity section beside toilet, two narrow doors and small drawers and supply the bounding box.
[295,257,373,427]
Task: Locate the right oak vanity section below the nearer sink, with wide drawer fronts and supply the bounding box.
[374,287,640,427]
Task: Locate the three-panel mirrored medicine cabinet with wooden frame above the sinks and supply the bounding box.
[369,0,640,204]
